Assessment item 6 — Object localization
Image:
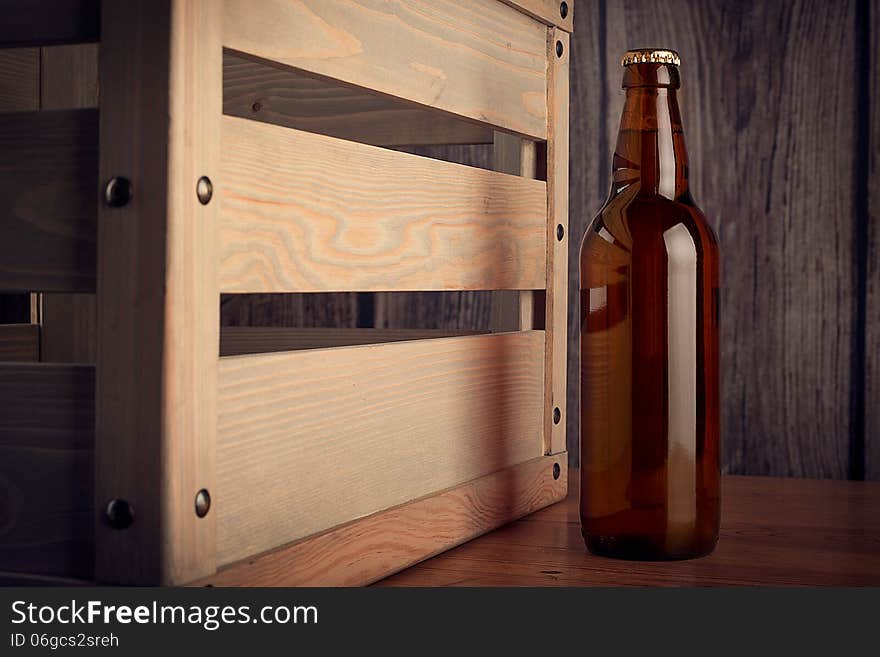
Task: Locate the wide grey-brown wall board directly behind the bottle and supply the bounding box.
[600,0,862,478]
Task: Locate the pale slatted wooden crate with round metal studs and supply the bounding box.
[0,0,573,585]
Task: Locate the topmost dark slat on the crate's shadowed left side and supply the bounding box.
[0,0,101,48]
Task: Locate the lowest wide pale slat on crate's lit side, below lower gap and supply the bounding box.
[216,331,544,564]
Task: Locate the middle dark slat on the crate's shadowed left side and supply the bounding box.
[0,109,98,292]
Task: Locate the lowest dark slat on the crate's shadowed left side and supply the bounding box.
[0,363,95,577]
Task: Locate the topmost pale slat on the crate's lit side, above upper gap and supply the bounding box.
[224,0,547,139]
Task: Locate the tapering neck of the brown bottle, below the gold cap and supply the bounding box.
[611,63,690,200]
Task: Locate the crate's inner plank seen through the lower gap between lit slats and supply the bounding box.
[218,326,478,356]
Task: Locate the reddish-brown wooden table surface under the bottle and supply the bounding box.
[378,471,880,586]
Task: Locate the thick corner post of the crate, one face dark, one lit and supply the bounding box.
[95,0,222,584]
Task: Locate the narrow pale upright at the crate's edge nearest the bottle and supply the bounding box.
[544,28,570,454]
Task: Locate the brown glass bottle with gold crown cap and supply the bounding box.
[580,50,720,559]
